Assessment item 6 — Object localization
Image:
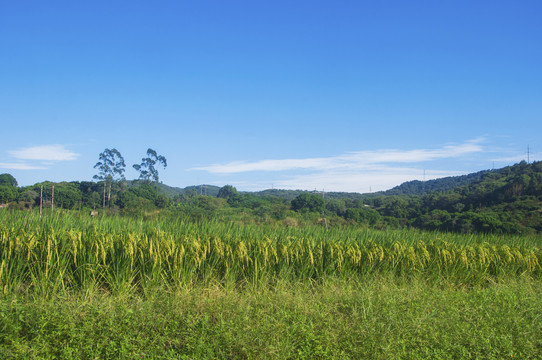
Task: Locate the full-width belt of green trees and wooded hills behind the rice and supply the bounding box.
[0,162,542,233]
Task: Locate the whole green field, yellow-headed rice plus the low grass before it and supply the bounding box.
[0,212,542,359]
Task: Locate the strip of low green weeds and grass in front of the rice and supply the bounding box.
[0,278,542,359]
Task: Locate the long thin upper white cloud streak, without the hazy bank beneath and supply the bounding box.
[192,139,482,174]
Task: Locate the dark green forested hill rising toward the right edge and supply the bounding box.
[369,162,542,233]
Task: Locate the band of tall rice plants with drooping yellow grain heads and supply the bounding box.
[0,211,542,296]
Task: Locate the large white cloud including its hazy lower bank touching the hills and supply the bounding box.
[193,138,484,192]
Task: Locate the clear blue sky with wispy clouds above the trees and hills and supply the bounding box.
[0,0,542,192]
